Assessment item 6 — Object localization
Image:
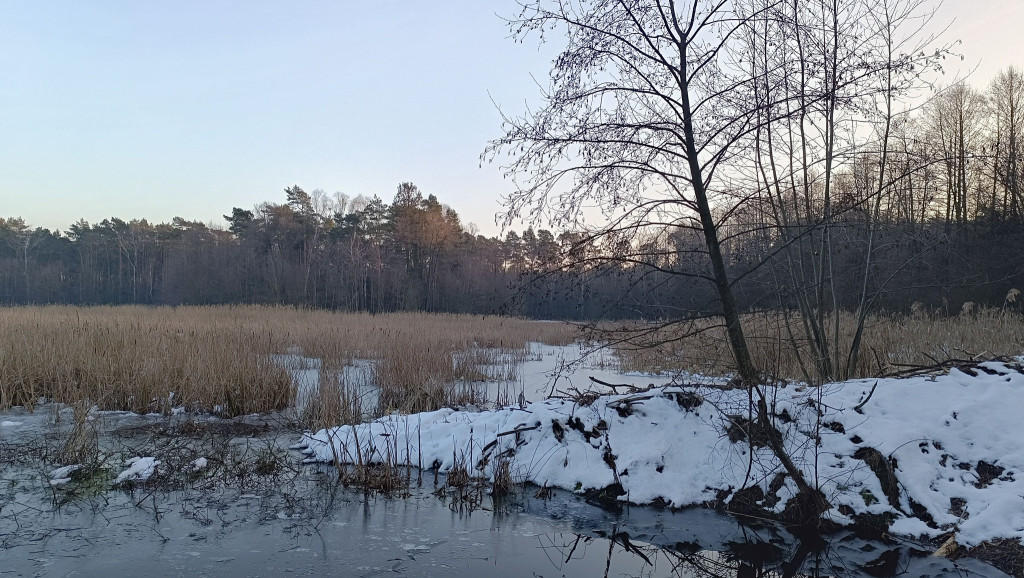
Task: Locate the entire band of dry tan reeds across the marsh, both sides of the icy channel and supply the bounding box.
[0,306,1024,418]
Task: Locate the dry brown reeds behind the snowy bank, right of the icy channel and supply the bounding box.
[604,308,1024,381]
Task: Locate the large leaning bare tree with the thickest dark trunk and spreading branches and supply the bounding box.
[484,0,782,382]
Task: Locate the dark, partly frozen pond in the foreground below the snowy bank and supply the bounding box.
[0,409,1001,577]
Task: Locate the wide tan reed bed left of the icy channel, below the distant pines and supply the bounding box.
[0,305,577,422]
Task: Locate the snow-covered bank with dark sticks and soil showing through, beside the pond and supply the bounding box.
[299,356,1024,546]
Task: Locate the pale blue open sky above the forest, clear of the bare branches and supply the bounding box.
[0,0,1024,235]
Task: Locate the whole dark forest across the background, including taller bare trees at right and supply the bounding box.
[0,69,1024,320]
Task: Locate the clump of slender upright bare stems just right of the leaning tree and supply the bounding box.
[744,0,941,380]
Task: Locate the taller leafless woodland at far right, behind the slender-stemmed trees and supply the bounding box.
[726,67,1024,313]
